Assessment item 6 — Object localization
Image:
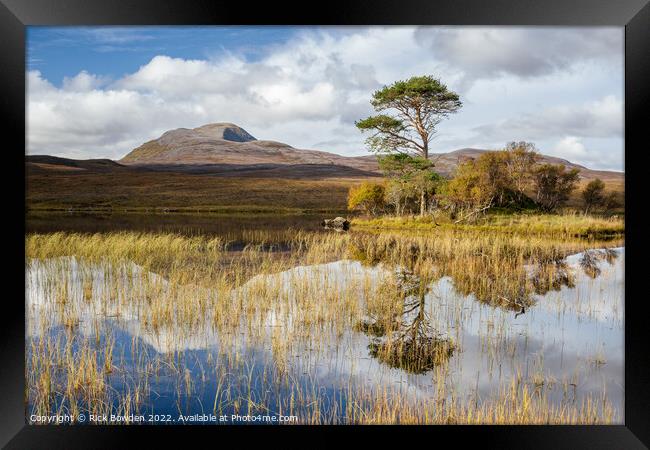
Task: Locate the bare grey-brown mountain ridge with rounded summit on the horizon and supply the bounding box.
[119,123,624,183]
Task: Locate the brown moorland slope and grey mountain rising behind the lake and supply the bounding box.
[25,123,625,212]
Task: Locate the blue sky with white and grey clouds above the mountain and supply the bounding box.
[26,26,624,171]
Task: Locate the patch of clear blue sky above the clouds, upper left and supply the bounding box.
[27,26,300,86]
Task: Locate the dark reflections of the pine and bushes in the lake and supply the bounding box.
[355,244,618,374]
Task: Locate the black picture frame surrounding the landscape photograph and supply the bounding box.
[0,0,650,449]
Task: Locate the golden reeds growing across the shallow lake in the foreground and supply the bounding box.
[26,228,620,424]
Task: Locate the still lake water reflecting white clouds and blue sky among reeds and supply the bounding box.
[26,214,624,423]
